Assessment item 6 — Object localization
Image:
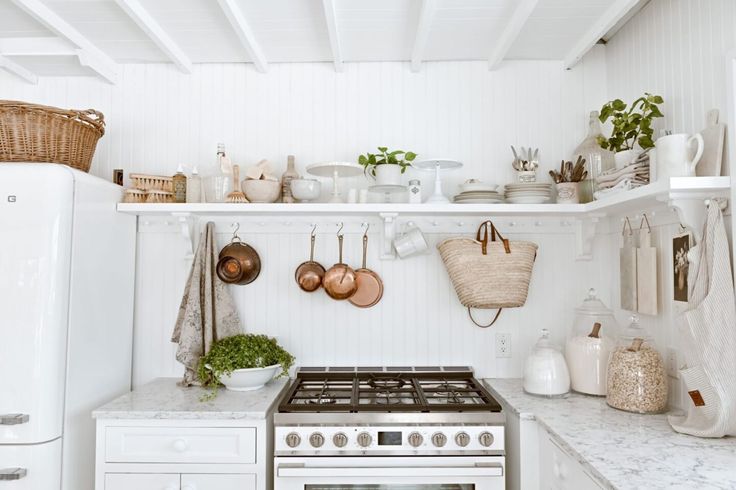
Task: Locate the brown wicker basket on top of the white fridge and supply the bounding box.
[0,100,105,172]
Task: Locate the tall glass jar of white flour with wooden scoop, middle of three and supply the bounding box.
[565,289,618,396]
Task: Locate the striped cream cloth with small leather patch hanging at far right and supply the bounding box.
[669,205,736,437]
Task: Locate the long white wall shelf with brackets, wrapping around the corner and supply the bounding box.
[118,177,731,260]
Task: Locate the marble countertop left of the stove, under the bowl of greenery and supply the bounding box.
[92,378,289,419]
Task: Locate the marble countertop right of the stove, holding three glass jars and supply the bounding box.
[483,379,736,490]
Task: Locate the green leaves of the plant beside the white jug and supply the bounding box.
[598,93,664,152]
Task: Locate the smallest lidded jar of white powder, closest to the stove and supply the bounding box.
[524,329,570,397]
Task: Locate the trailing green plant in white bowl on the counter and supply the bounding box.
[197,334,294,394]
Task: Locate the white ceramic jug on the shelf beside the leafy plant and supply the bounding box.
[657,133,705,180]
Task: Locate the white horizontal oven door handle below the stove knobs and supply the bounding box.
[276,463,503,478]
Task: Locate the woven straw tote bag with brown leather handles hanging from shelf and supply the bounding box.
[437,220,537,328]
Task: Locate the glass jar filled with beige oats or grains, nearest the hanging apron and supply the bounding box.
[606,315,668,413]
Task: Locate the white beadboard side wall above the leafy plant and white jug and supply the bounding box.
[606,0,736,167]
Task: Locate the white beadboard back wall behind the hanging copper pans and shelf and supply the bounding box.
[0,52,606,384]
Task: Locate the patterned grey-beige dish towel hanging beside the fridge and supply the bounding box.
[171,222,242,386]
